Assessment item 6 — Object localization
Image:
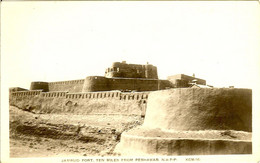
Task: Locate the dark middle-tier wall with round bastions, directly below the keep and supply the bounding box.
[30,76,173,93]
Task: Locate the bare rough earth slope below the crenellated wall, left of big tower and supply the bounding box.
[10,106,143,157]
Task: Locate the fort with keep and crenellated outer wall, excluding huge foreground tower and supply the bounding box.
[9,61,211,116]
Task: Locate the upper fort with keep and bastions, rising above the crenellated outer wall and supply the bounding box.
[25,61,209,93]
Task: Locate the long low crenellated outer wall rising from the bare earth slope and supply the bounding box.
[10,90,150,116]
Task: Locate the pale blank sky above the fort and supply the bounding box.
[1,1,260,88]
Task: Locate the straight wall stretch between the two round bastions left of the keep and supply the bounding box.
[49,79,85,92]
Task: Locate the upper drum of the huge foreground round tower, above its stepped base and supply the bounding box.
[143,88,252,132]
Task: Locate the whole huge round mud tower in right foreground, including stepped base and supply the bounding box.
[115,88,252,156]
